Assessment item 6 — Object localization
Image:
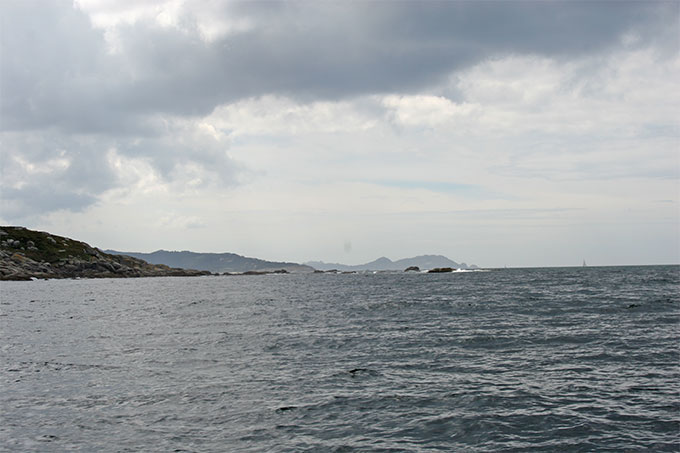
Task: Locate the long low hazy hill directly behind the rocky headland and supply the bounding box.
[106,250,314,273]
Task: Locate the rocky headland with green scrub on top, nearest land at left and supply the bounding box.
[0,226,210,280]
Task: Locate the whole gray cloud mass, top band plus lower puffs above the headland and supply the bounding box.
[0,0,680,218]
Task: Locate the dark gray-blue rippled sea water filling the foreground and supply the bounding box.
[0,266,680,452]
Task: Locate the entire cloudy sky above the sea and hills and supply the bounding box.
[0,0,680,267]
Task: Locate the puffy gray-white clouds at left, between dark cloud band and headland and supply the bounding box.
[0,119,239,221]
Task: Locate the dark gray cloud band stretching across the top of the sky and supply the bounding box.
[0,2,679,134]
